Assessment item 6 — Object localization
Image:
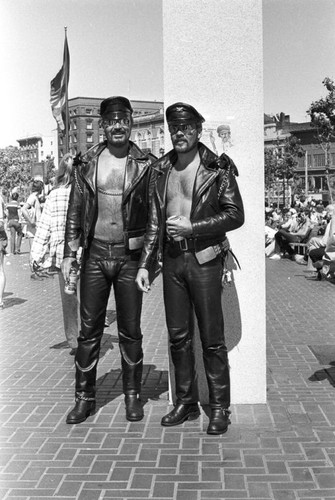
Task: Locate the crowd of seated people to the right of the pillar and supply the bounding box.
[265,196,335,280]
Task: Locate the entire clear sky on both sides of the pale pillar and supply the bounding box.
[0,0,335,148]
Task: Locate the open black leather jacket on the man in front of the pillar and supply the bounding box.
[139,142,244,269]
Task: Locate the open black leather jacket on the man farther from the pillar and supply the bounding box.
[64,141,156,258]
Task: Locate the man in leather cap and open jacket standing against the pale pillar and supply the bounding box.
[136,102,244,434]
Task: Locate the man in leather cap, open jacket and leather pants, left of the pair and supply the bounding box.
[62,96,156,424]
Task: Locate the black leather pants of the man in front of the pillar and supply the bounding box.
[163,251,230,408]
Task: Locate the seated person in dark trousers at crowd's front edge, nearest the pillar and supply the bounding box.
[270,209,313,260]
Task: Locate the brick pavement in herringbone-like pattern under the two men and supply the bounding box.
[0,240,335,500]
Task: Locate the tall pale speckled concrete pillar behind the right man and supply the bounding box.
[163,0,266,404]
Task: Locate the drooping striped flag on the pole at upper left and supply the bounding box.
[50,35,70,130]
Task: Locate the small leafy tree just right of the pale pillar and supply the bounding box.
[264,135,304,206]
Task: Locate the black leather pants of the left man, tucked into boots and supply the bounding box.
[75,240,143,400]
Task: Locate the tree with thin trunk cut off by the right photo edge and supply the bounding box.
[307,77,335,203]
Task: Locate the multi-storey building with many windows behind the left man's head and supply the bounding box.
[58,97,164,158]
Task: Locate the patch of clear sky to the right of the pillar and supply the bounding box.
[264,0,335,122]
